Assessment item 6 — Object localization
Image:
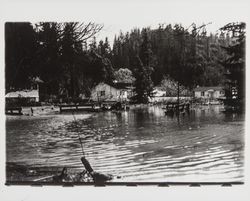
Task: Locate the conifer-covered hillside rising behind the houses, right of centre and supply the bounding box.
[111,24,231,88]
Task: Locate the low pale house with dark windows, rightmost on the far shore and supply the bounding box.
[194,86,225,100]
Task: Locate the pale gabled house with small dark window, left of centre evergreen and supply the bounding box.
[91,82,133,101]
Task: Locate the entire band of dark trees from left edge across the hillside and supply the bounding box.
[5,22,244,102]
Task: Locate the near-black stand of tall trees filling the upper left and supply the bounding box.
[5,23,113,98]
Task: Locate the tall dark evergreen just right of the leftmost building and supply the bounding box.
[36,22,62,95]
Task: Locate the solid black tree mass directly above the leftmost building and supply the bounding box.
[5,22,38,92]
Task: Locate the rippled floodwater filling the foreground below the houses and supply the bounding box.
[6,106,244,182]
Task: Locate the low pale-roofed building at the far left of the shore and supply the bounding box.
[5,89,39,104]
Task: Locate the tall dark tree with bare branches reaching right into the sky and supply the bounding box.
[61,22,102,98]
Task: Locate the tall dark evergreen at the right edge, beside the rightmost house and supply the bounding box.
[221,22,246,109]
